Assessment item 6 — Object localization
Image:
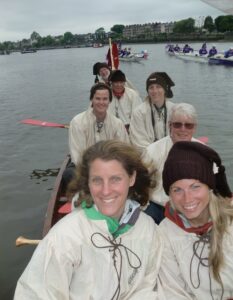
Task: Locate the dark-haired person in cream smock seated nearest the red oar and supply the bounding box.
[63,83,129,186]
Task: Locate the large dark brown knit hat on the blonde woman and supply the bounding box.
[163,141,232,197]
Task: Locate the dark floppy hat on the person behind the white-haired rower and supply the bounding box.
[146,72,175,98]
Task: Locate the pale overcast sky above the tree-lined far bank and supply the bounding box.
[0,0,224,42]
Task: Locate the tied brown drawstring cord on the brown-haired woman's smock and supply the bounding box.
[91,232,142,300]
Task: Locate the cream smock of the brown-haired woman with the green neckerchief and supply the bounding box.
[14,208,165,300]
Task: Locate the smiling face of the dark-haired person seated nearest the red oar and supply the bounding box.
[91,89,110,119]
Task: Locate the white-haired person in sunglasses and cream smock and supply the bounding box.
[142,103,201,224]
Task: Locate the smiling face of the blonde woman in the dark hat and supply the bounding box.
[169,179,210,227]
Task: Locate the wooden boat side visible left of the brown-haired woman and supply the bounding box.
[42,155,71,237]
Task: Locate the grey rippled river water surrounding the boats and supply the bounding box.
[0,43,233,300]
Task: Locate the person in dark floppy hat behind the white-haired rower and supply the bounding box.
[129,72,175,151]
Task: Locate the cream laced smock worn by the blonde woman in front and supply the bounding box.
[159,218,233,300]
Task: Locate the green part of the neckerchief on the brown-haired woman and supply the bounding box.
[81,201,132,237]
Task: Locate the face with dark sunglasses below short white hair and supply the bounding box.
[169,115,196,143]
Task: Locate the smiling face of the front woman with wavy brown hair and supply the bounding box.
[88,158,136,220]
